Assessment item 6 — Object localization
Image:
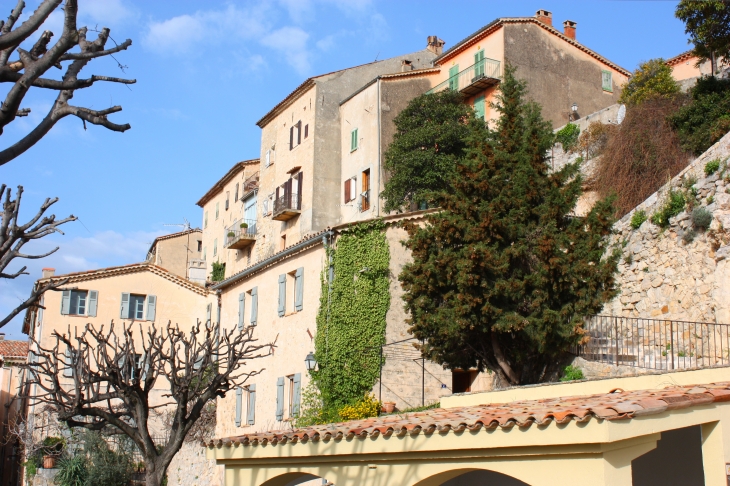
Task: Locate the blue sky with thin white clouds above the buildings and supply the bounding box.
[0,0,689,339]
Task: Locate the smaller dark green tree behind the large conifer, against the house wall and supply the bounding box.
[381,89,472,211]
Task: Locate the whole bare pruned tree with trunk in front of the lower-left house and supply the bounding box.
[28,321,275,486]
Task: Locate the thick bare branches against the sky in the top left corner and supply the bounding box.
[0,0,136,165]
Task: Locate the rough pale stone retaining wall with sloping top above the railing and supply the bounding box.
[603,129,730,323]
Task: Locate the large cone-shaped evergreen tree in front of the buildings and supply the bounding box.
[400,66,619,385]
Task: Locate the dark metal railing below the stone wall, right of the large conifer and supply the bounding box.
[573,315,730,370]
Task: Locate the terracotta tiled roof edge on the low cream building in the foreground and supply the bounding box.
[206,382,730,447]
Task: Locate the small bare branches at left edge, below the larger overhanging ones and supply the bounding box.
[0,184,77,327]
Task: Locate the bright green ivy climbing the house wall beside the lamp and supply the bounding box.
[312,220,390,409]
